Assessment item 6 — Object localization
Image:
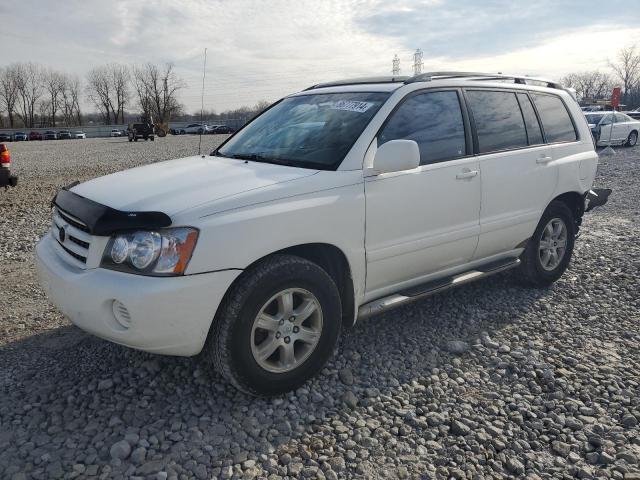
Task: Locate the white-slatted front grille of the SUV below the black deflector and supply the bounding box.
[51,207,92,268]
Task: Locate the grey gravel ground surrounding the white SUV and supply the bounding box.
[0,137,640,480]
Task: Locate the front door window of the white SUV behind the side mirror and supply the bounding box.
[378,91,466,165]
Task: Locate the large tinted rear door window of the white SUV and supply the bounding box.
[467,90,527,153]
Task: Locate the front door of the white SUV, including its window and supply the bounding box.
[365,90,481,299]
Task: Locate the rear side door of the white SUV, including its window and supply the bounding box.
[465,89,558,259]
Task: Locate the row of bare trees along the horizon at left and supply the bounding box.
[0,62,185,128]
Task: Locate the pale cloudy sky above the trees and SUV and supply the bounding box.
[0,0,640,111]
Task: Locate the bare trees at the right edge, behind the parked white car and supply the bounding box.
[560,45,640,110]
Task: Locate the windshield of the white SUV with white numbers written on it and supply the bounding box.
[213,92,389,170]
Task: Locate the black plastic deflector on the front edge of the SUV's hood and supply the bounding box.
[53,187,171,236]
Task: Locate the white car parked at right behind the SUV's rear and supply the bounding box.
[585,112,640,147]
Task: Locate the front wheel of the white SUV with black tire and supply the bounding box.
[208,254,342,396]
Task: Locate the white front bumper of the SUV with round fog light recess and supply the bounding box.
[36,234,240,356]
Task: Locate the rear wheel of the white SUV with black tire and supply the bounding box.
[520,201,576,287]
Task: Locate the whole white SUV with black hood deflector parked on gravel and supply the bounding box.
[37,72,610,395]
